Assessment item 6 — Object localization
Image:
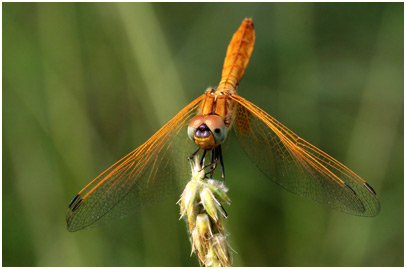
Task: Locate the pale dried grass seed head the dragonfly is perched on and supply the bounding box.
[178,157,231,267]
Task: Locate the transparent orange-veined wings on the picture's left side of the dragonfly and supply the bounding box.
[66,95,203,231]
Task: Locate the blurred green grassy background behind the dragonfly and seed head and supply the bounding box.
[2,3,404,266]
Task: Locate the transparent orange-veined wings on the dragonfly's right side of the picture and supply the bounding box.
[232,95,380,216]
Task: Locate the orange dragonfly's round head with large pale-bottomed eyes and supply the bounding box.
[187,114,227,150]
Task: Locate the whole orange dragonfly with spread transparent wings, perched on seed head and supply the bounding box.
[66,18,380,231]
